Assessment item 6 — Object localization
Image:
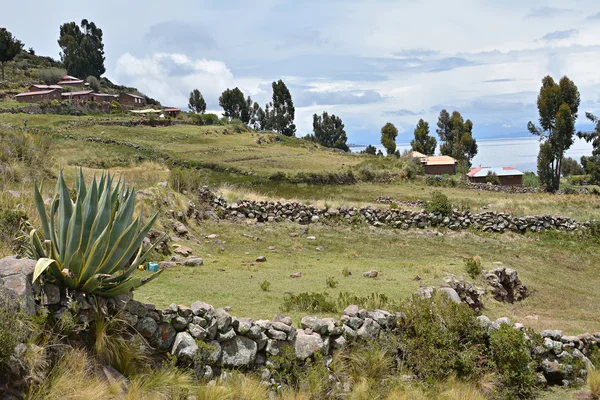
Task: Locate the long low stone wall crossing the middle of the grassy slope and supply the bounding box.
[197,188,597,233]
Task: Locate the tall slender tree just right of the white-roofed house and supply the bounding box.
[527,76,580,191]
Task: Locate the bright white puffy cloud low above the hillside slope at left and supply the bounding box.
[115,53,239,109]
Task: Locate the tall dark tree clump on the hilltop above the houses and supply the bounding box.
[58,19,106,78]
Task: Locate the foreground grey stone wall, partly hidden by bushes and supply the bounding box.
[0,257,600,385]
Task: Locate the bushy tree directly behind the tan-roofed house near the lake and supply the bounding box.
[436,110,478,173]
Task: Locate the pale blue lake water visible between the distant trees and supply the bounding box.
[350,137,592,172]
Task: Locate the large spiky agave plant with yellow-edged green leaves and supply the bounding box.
[30,170,160,297]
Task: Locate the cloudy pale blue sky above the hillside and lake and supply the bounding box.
[5,0,600,144]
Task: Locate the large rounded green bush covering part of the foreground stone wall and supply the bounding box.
[399,294,486,383]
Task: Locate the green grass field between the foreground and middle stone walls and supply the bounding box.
[136,217,600,333]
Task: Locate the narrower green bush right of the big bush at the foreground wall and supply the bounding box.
[489,324,536,398]
